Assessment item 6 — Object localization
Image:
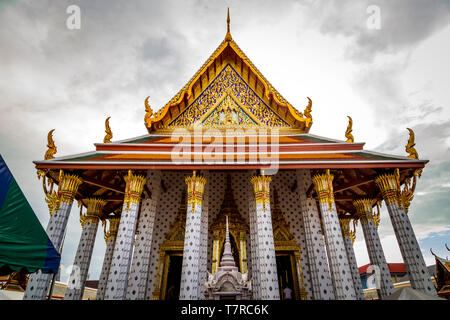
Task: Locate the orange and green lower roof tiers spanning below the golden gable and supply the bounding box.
[35,132,428,170]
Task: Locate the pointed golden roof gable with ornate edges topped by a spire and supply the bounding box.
[146,10,312,133]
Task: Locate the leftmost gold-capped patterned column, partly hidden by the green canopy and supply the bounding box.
[23,174,82,300]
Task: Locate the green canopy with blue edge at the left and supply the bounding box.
[0,155,61,275]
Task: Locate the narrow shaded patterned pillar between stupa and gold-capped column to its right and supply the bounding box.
[247,172,262,300]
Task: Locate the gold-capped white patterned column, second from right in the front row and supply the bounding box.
[312,170,356,300]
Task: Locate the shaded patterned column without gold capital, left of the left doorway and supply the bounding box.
[127,170,161,300]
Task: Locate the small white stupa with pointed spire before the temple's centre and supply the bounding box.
[205,216,251,300]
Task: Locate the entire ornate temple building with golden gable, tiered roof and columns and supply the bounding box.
[24,10,436,300]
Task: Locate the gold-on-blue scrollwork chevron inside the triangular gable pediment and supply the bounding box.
[167,65,289,128]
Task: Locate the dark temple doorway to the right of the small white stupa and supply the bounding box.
[276,252,300,300]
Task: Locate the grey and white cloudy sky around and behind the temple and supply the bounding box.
[0,0,450,281]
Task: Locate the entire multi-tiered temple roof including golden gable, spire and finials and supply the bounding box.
[35,10,427,220]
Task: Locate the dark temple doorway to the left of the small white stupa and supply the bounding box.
[161,252,183,300]
